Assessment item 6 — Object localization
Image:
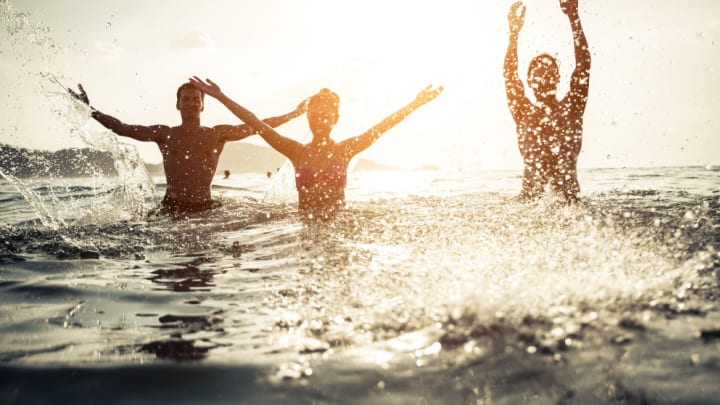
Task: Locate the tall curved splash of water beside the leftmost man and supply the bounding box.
[0,1,156,224]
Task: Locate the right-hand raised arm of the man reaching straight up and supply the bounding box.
[560,0,590,107]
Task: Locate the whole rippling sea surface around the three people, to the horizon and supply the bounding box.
[0,167,720,404]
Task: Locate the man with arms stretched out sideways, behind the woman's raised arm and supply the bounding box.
[68,83,307,215]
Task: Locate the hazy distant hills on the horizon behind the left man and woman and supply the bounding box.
[0,142,414,178]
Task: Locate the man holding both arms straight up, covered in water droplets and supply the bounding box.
[504,0,590,202]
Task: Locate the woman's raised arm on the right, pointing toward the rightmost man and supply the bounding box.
[340,86,443,158]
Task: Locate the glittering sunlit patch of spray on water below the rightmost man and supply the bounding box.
[243,189,719,366]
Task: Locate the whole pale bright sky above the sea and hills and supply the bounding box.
[0,0,720,168]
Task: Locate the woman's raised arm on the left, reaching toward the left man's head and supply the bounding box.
[190,76,302,160]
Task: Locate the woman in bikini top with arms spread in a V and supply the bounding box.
[190,77,443,213]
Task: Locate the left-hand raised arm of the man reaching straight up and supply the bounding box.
[503,2,525,117]
